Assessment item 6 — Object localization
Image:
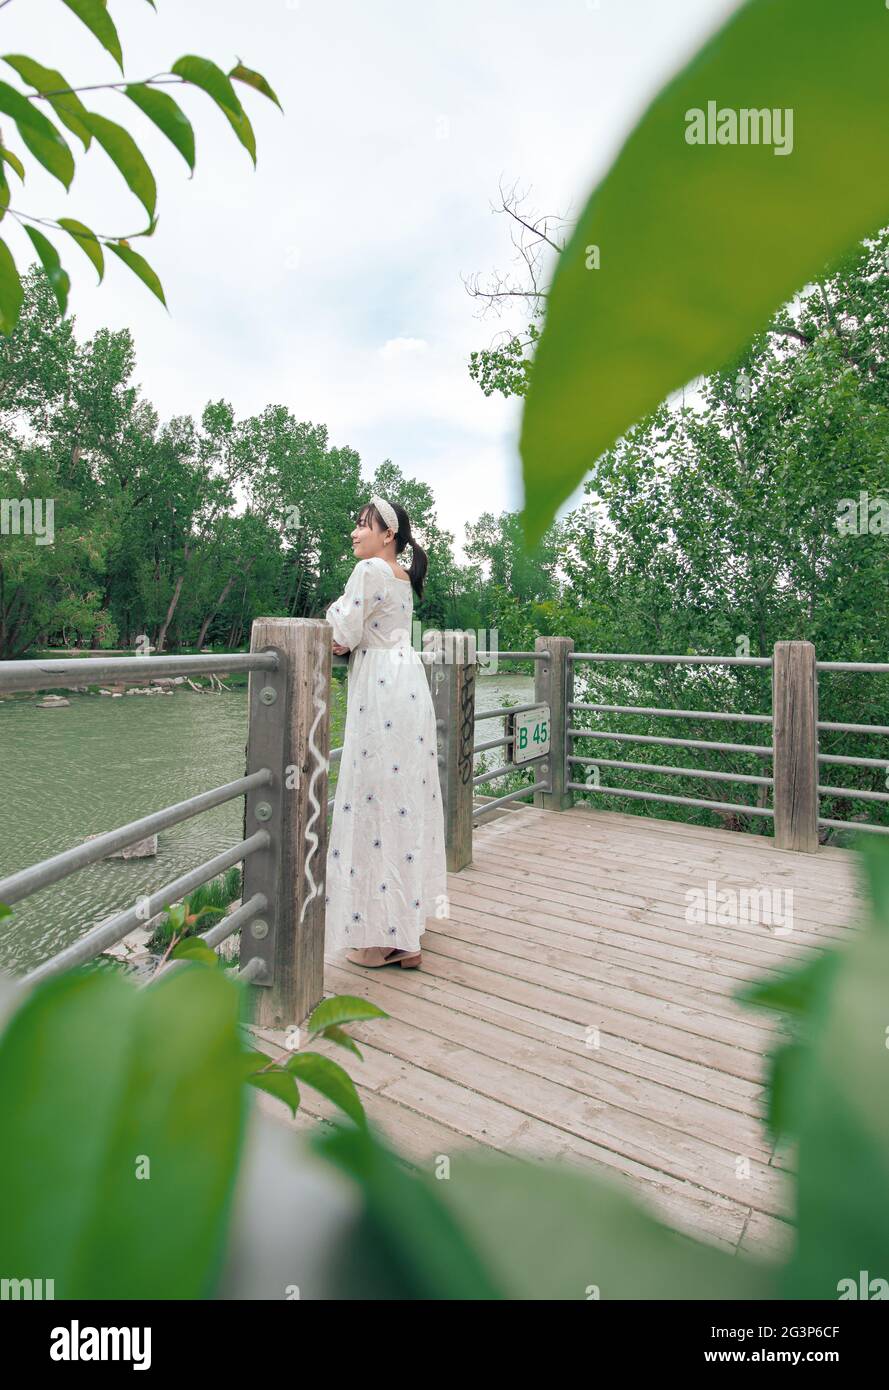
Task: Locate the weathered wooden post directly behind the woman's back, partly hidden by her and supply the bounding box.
[426,628,475,873]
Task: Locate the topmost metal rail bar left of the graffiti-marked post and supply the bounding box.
[0,652,278,691]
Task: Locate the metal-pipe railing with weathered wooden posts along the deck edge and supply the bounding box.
[0,631,889,1027]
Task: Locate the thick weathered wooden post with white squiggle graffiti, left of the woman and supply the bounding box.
[240,617,331,1029]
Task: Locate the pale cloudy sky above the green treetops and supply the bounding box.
[0,0,736,557]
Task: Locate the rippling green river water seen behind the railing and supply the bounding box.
[0,674,533,974]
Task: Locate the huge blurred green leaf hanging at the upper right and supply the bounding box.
[521,0,889,545]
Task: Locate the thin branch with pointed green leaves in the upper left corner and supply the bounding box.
[0,0,283,335]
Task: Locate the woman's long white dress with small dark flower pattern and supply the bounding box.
[324,556,447,952]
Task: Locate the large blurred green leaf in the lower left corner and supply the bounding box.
[0,970,247,1298]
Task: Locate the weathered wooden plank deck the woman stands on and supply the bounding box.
[248,806,858,1257]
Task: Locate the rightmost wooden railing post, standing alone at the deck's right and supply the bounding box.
[772,642,818,853]
